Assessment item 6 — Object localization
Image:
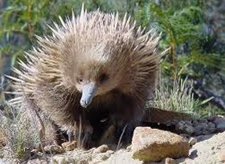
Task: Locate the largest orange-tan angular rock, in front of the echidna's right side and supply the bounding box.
[131,127,190,162]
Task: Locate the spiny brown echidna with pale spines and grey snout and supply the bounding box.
[8,9,159,145]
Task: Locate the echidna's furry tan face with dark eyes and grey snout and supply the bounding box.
[61,42,126,108]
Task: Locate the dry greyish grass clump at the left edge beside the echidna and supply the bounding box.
[0,102,39,161]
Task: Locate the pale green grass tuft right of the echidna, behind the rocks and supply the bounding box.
[151,79,211,117]
